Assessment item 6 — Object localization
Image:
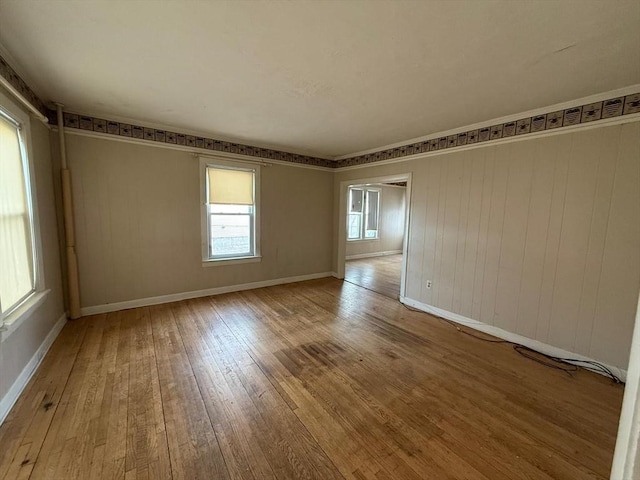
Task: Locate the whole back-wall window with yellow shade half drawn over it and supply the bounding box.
[203,158,260,261]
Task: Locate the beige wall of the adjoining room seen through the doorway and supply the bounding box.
[346,185,406,257]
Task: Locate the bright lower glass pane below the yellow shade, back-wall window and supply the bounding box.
[209,214,253,257]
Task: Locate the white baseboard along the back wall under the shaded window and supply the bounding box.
[80,272,334,316]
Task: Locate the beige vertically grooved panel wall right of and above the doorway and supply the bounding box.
[334,122,640,368]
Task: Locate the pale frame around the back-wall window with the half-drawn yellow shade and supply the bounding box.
[200,156,262,267]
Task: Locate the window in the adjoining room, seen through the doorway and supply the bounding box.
[347,187,380,240]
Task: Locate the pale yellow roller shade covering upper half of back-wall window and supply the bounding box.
[207,167,254,205]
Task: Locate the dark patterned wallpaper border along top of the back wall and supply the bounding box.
[52,112,335,168]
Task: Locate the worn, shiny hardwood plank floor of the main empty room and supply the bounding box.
[0,279,623,480]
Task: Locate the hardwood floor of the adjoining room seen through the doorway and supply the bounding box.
[344,254,402,299]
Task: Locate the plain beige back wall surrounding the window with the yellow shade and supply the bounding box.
[61,134,333,307]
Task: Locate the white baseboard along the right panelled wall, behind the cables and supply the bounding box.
[400,297,627,382]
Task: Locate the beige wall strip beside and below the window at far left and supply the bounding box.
[0,97,64,399]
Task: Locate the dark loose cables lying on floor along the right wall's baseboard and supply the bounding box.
[400,302,624,383]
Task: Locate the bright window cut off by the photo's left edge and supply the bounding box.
[0,109,37,320]
